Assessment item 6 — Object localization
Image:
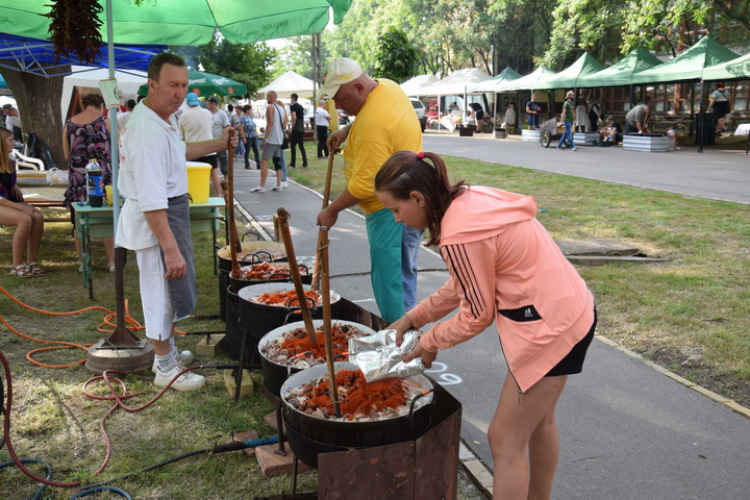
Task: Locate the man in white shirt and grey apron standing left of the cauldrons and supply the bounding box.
[116,52,236,391]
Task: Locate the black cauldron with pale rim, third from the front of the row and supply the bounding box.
[238,283,341,339]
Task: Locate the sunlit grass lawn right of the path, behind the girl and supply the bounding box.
[291,150,750,407]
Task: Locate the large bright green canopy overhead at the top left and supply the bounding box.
[0,0,352,45]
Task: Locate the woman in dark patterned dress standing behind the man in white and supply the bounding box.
[62,94,115,272]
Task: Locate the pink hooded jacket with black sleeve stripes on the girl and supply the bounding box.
[407,186,594,392]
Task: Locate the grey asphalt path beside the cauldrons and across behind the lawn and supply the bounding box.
[235,134,750,500]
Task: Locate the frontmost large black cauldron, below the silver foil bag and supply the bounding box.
[281,362,434,467]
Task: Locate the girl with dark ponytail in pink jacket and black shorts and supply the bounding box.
[375,151,596,500]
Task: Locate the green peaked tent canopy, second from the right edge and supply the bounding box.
[631,35,739,84]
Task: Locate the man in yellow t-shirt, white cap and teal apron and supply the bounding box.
[317,57,422,322]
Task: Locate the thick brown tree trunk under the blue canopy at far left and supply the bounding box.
[0,66,70,169]
